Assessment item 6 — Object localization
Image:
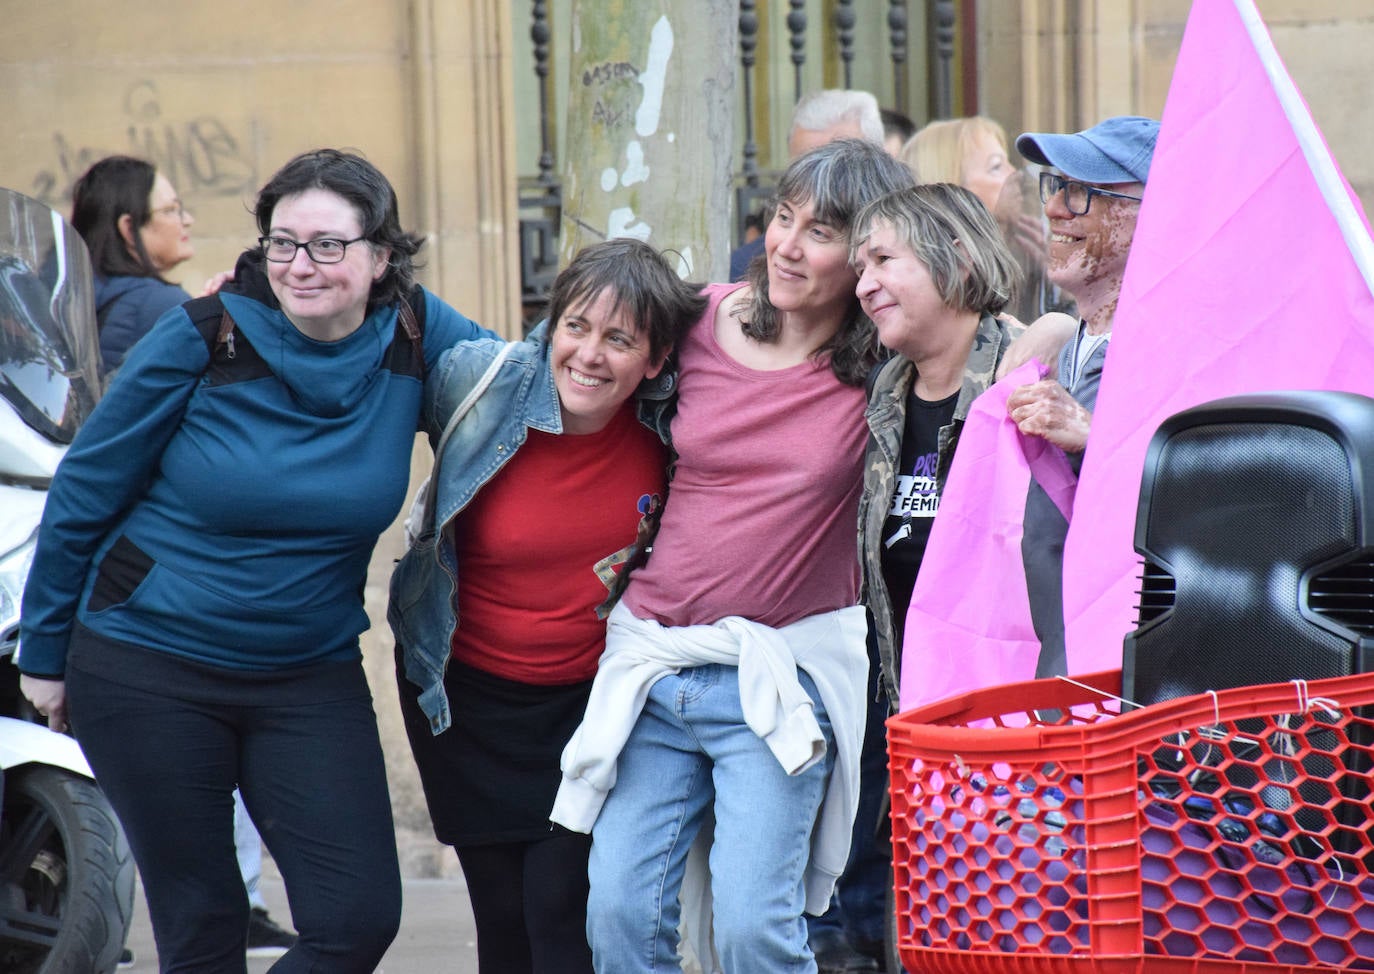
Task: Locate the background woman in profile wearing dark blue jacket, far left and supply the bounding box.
[71,155,203,375]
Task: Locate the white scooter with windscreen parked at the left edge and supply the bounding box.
[0,190,135,974]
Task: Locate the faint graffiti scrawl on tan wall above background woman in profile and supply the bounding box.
[29,81,258,209]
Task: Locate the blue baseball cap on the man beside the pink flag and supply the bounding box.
[1017,115,1160,183]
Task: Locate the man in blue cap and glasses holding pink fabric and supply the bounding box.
[1007,115,1160,676]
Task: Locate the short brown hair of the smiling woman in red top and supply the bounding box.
[548,236,706,363]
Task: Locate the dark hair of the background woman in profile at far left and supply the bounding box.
[71,155,162,280]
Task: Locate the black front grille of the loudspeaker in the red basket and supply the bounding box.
[1125,422,1357,703]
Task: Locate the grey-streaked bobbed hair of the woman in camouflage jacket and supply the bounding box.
[849,183,1020,315]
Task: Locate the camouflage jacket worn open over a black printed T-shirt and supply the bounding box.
[859,315,1011,710]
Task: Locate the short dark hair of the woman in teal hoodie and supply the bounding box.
[253,148,414,310]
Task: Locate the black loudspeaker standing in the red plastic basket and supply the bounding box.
[1121,392,1374,703]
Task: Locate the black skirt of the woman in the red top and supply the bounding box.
[396,648,592,846]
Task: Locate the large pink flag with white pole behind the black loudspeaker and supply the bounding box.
[1066,0,1374,673]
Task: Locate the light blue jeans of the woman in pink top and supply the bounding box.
[587,664,835,974]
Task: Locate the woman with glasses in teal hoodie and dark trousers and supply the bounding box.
[19,150,491,974]
